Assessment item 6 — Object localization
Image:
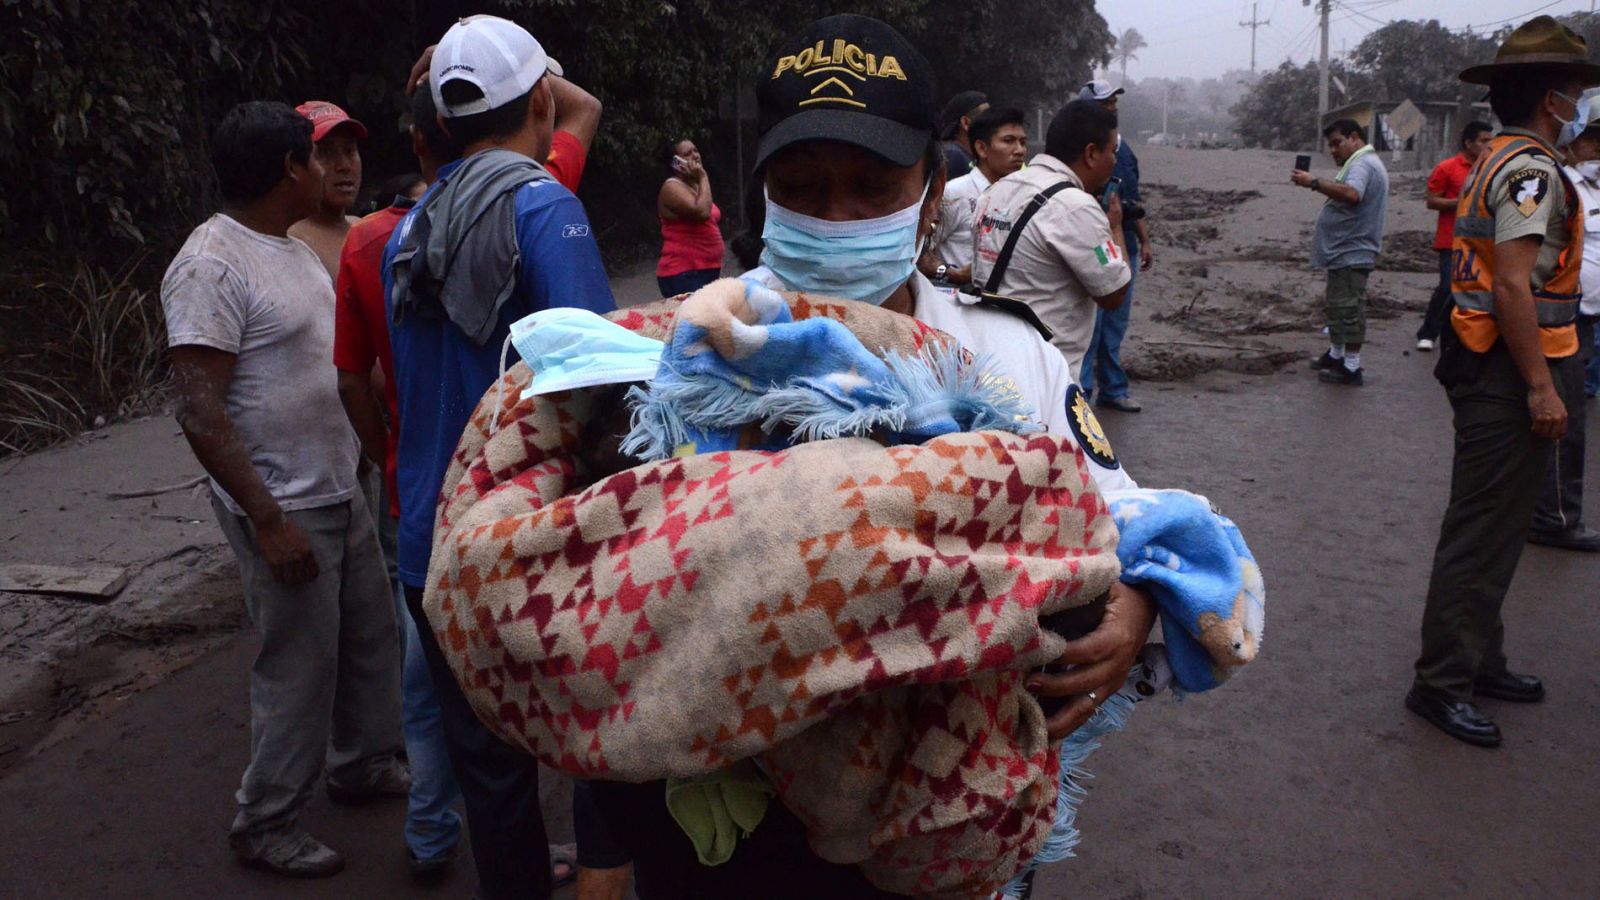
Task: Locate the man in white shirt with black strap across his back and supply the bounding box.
[973,99,1131,372]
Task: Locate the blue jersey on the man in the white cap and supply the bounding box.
[382,160,616,588]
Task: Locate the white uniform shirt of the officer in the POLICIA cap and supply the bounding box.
[741,266,1139,495]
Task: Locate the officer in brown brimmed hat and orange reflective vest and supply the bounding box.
[1406,16,1600,746]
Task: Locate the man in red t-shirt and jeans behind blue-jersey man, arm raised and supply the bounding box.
[333,70,600,876]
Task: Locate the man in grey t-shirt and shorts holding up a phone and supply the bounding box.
[1290,119,1389,386]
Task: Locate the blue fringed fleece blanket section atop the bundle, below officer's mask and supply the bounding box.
[622,282,1040,460]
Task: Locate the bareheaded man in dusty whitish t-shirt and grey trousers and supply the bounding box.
[162,102,411,878]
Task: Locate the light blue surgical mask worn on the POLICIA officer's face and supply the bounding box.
[762,184,928,306]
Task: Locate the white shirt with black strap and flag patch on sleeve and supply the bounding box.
[973,154,1133,372]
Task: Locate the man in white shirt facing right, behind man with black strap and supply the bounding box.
[917,106,1027,285]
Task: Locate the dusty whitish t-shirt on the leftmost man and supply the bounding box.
[162,213,360,516]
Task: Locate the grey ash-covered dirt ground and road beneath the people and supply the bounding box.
[0,147,1600,898]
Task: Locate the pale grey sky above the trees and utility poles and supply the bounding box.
[1096,0,1600,80]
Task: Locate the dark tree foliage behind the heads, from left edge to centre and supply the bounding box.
[0,0,1112,273]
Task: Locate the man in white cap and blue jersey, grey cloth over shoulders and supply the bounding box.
[384,16,616,900]
